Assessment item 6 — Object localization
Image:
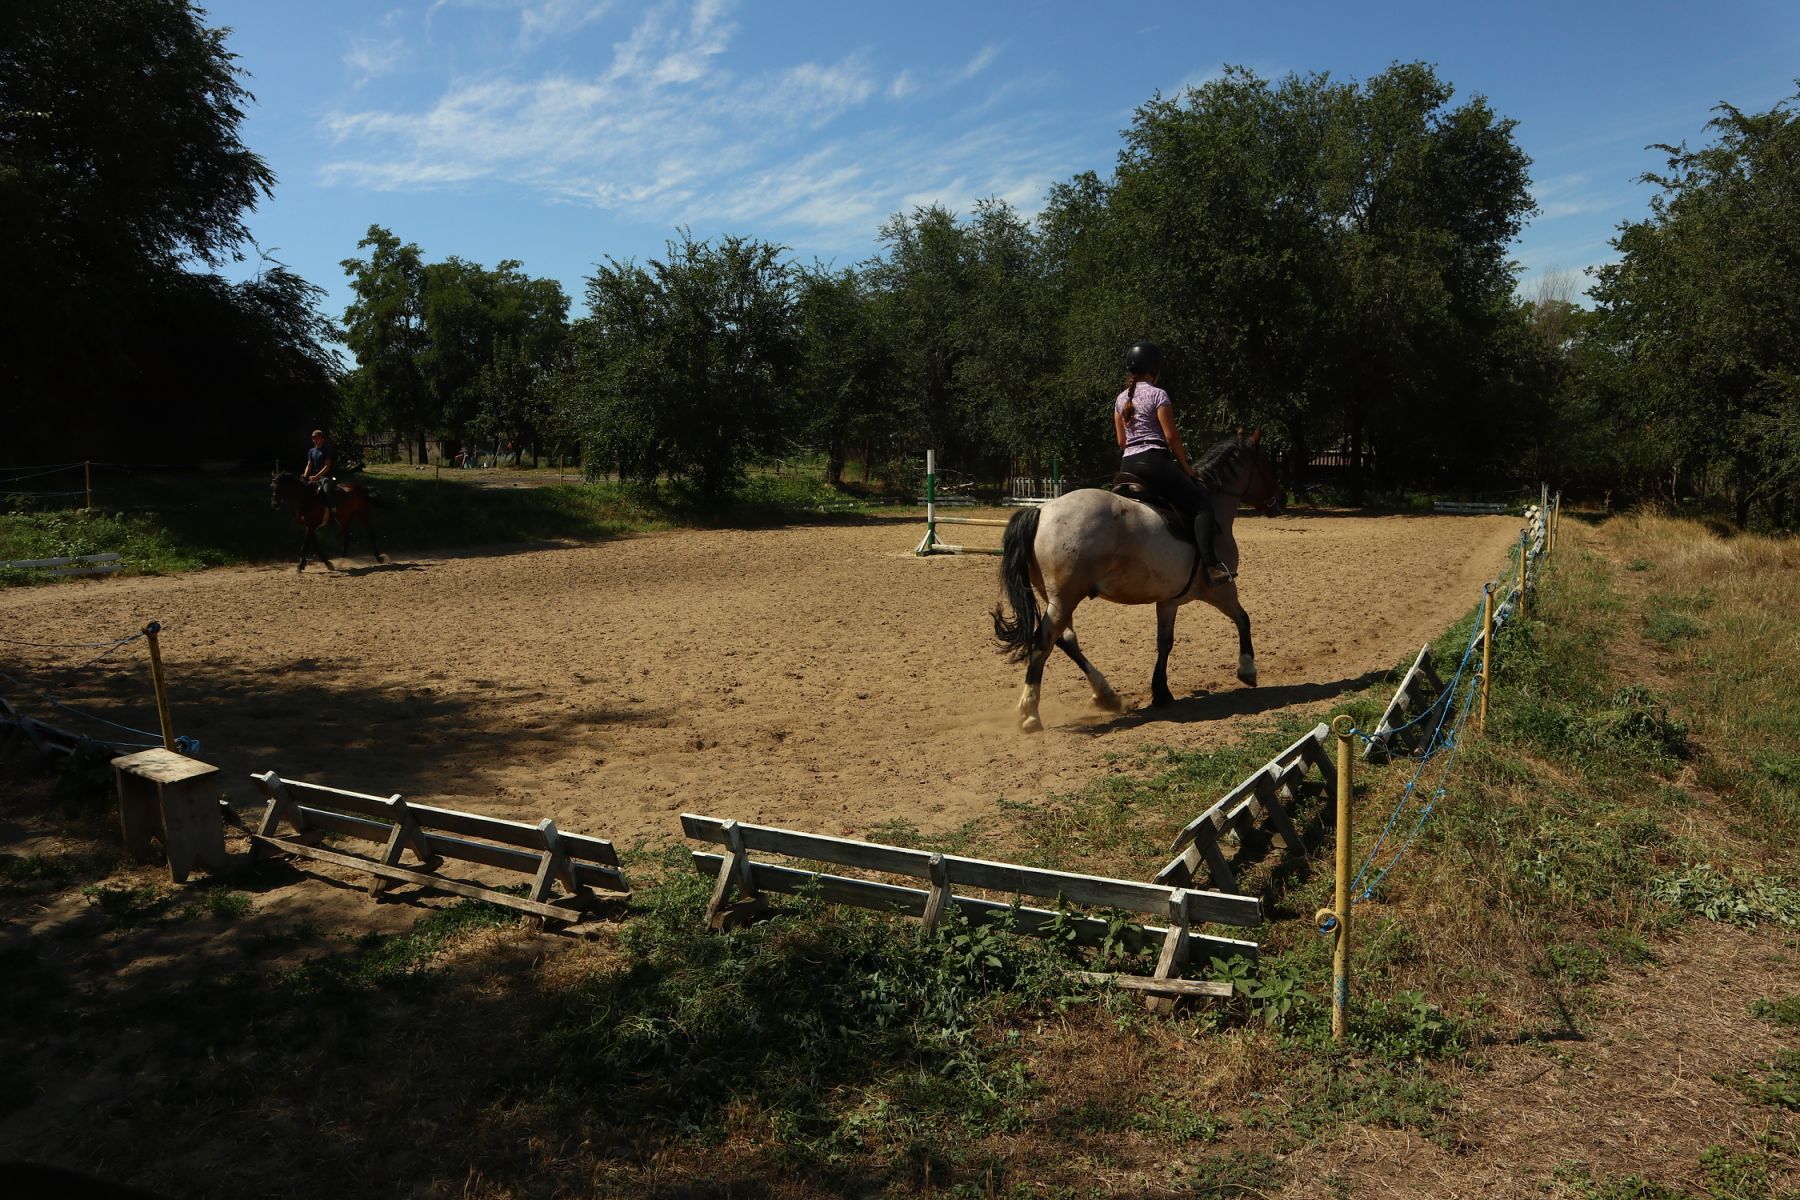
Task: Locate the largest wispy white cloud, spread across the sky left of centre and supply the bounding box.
[324,0,1075,243]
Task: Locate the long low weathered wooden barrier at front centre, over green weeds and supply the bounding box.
[680,813,1262,997]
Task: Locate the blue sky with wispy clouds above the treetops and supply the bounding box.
[207,0,1800,317]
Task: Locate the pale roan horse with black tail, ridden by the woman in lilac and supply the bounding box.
[994,430,1287,734]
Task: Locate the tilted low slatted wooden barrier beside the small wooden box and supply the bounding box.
[250,772,632,925]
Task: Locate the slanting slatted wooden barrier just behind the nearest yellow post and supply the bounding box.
[1156,723,1336,892]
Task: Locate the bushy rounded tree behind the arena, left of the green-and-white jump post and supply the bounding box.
[574,232,797,502]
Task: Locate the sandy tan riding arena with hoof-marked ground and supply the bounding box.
[0,516,1517,846]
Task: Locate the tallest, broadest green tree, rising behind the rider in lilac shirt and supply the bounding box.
[1094,63,1532,489]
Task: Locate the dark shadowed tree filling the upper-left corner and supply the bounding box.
[0,0,337,457]
